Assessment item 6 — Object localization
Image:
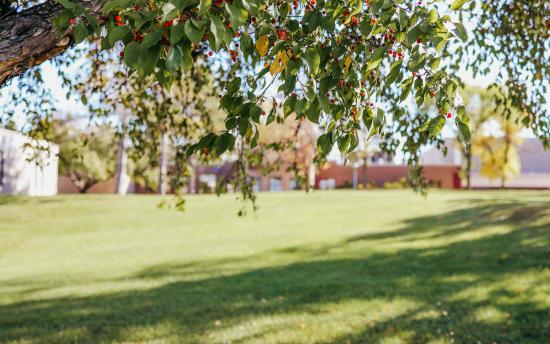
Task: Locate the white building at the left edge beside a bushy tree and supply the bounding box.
[0,128,59,196]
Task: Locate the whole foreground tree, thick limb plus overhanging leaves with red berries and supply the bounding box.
[0,0,548,203]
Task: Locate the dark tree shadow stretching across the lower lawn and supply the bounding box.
[0,200,550,343]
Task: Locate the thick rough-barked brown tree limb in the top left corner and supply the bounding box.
[0,0,100,85]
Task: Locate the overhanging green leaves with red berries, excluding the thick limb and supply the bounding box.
[57,0,470,159]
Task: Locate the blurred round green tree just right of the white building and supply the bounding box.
[49,118,116,193]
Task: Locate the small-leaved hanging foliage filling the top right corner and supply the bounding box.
[454,0,550,142]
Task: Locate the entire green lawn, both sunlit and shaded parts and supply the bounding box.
[0,191,550,343]
